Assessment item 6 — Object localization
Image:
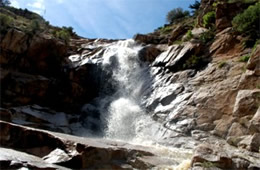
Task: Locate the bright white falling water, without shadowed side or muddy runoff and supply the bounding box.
[100,40,155,141]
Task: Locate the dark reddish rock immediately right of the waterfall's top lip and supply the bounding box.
[138,45,161,63]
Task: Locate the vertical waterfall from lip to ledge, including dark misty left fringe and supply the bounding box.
[84,39,156,141]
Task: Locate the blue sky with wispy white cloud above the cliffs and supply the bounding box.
[10,0,195,39]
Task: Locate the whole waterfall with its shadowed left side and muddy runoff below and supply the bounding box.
[79,40,193,168]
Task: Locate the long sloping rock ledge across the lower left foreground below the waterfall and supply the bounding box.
[0,121,189,169]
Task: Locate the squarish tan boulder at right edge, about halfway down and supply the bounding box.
[233,89,260,117]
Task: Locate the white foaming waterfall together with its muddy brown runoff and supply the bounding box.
[82,40,191,169]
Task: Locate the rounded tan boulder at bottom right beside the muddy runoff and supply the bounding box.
[191,144,232,169]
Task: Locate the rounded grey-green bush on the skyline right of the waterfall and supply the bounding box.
[166,8,190,23]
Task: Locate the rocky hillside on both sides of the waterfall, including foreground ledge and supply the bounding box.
[0,0,260,170]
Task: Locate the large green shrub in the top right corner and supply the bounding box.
[232,2,260,39]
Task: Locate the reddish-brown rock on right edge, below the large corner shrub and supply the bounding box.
[247,45,260,76]
